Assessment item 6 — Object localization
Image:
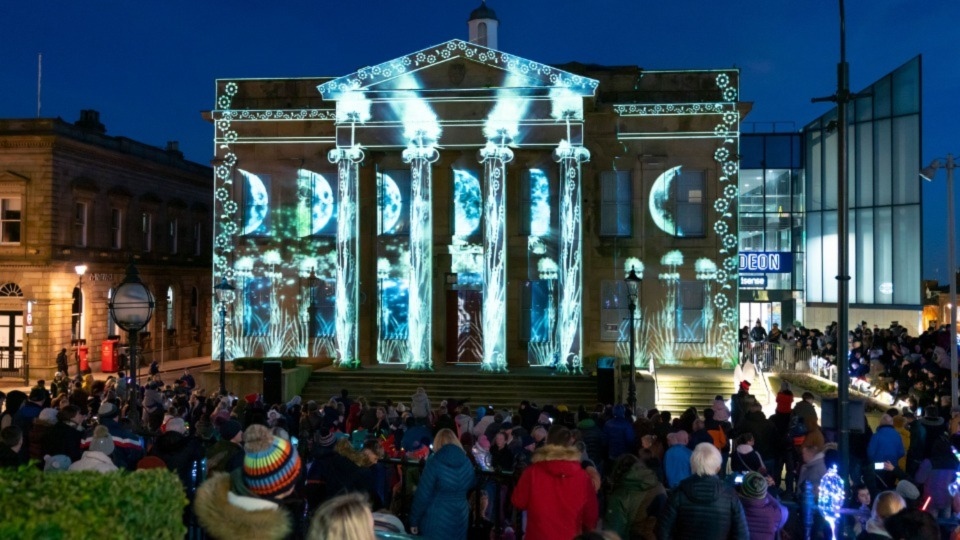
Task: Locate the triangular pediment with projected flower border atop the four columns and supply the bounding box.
[317,39,599,100]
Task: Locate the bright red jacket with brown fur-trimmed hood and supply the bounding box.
[511,445,599,540]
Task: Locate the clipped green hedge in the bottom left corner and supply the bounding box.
[0,466,187,540]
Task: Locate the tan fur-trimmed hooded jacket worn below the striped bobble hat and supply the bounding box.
[193,474,291,540]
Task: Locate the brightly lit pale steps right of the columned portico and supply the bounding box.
[656,368,776,416]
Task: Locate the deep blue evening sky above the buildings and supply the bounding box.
[0,0,960,281]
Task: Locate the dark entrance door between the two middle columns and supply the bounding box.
[446,289,483,364]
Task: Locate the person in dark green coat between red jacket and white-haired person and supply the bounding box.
[603,454,667,540]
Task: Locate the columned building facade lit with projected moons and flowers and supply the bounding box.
[211,37,748,371]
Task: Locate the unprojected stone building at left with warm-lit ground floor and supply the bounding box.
[0,111,213,380]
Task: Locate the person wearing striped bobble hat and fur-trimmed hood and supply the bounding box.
[194,424,300,540]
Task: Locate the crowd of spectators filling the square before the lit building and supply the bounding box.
[0,331,960,540]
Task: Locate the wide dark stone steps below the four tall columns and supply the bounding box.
[301,366,597,411]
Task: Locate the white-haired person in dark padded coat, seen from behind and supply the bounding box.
[657,443,750,540]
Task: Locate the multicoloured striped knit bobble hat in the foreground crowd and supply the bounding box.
[243,424,300,497]
